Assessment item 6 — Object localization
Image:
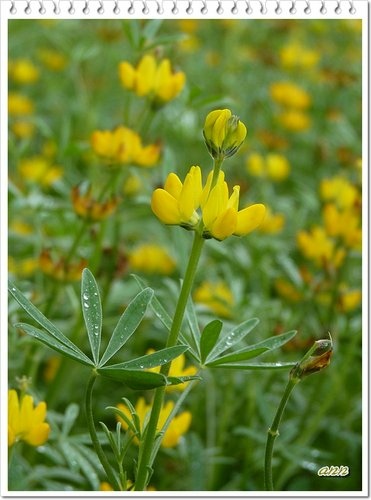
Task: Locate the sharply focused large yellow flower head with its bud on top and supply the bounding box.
[151,110,265,240]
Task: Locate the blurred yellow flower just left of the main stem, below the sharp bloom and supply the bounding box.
[128,243,176,275]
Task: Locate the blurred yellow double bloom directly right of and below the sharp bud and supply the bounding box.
[246,153,290,181]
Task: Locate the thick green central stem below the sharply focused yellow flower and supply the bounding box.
[135,232,205,491]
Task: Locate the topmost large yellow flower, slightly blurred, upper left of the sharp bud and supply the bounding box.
[119,54,185,104]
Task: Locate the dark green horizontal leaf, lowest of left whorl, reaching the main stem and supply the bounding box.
[97,366,166,390]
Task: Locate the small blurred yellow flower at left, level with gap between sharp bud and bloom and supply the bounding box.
[18,156,63,186]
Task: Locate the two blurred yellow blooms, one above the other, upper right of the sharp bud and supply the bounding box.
[270,82,311,132]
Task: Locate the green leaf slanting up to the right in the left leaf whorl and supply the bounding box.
[100,288,153,366]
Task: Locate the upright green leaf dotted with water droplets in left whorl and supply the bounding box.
[81,269,102,366]
